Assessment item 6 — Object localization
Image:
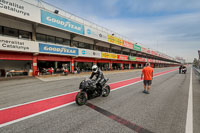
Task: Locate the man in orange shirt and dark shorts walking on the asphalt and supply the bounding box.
[141,62,153,94]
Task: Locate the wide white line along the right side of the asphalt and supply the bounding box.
[185,68,193,133]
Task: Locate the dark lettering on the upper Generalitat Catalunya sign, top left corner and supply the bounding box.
[0,0,30,16]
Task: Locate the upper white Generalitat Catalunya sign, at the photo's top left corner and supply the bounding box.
[0,0,40,23]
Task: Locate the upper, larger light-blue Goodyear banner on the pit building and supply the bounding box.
[41,10,84,35]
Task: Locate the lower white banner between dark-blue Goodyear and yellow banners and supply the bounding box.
[79,49,101,58]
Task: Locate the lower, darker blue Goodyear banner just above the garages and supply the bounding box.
[39,43,79,56]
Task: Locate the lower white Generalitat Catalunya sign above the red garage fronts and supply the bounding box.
[0,36,39,53]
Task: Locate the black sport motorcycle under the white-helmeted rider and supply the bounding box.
[76,79,110,105]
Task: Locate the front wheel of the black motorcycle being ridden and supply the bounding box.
[76,92,88,106]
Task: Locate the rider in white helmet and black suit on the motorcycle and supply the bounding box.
[90,65,105,94]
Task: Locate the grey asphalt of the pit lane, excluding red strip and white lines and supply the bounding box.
[0,68,200,133]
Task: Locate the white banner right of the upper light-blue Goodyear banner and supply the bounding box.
[84,26,108,42]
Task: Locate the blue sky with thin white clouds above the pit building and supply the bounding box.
[43,0,200,62]
